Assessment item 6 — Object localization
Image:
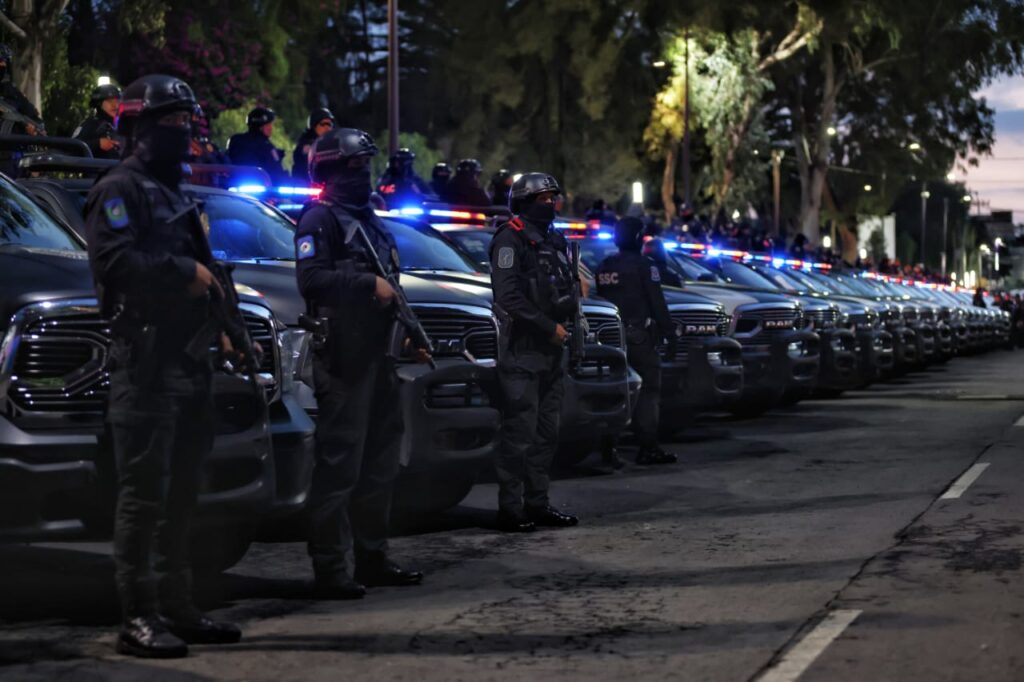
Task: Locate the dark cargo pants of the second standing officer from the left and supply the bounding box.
[309,353,402,580]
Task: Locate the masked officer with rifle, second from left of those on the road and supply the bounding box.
[295,128,424,599]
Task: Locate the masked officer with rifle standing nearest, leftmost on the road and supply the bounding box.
[85,75,242,657]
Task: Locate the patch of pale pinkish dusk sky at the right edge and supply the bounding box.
[956,76,1024,223]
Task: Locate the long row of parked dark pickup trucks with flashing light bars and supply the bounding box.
[0,138,1010,570]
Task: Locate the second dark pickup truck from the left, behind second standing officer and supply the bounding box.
[12,155,500,515]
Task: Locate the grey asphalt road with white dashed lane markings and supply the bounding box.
[0,352,1024,682]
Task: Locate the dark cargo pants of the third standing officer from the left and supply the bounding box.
[496,350,565,514]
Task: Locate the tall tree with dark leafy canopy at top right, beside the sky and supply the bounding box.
[773,0,1024,241]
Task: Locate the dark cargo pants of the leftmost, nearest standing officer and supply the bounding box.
[109,343,214,620]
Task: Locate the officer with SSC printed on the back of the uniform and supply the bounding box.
[595,217,679,464]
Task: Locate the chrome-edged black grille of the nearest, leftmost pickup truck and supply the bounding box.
[8,311,278,415]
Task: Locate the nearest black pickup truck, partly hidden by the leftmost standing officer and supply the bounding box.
[0,168,292,568]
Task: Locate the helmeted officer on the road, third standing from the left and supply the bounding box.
[490,173,579,532]
